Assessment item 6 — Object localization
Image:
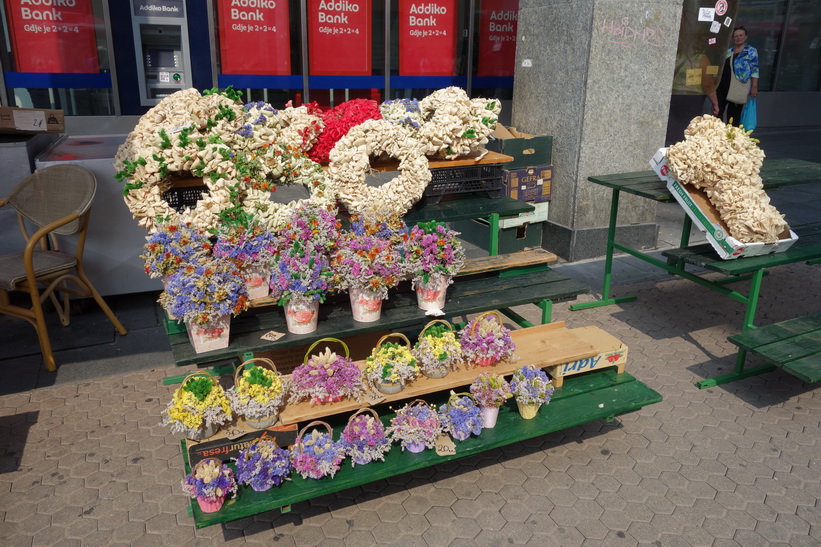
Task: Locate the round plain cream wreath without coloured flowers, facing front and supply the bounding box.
[328,120,431,215]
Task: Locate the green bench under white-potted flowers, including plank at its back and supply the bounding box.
[166,250,590,366]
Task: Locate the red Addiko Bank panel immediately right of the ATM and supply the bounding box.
[219,0,291,74]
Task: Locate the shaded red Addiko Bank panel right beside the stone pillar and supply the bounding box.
[476,0,519,76]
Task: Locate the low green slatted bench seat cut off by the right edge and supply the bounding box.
[727,312,821,382]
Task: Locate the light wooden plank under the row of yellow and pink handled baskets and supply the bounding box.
[279,323,597,425]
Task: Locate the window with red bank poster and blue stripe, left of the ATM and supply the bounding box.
[0,0,114,116]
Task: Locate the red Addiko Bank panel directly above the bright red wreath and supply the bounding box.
[308,0,373,76]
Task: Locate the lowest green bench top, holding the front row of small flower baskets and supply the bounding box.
[183,370,662,528]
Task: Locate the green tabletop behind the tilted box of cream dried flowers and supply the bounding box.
[588,158,821,202]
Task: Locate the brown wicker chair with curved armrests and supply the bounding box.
[0,164,126,372]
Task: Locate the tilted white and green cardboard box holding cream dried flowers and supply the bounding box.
[650,148,798,260]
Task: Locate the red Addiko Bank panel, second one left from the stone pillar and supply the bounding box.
[399,0,457,76]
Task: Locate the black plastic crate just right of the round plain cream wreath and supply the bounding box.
[425,163,504,203]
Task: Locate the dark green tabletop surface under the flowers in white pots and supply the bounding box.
[169,270,590,365]
